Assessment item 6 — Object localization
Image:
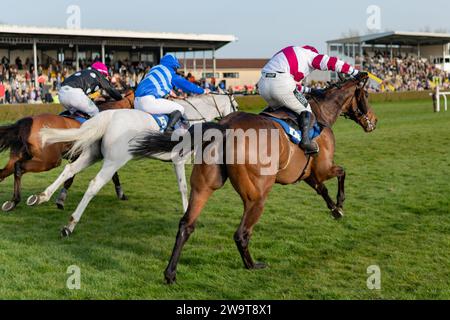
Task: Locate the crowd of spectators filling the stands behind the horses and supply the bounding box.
[0,52,450,104]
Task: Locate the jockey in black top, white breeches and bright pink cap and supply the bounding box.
[58,62,122,117]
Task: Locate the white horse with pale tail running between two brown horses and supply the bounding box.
[34,94,238,237]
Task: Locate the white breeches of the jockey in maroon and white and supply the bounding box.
[258,73,311,114]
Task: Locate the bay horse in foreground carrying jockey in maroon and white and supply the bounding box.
[133,74,378,284]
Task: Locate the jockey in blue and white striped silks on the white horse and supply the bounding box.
[134,54,209,132]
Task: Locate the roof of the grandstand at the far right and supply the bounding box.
[327,31,450,46]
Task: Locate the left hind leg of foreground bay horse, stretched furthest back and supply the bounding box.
[164,164,227,284]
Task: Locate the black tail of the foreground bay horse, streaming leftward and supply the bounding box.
[129,122,228,158]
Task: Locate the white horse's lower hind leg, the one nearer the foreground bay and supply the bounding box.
[61,156,131,237]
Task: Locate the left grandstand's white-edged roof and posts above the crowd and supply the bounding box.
[0,25,237,86]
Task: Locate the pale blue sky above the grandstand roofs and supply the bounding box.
[0,0,450,58]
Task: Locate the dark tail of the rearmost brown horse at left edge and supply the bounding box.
[0,118,33,156]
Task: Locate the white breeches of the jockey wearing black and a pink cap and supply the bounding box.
[58,86,99,117]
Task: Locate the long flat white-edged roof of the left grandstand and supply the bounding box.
[0,25,237,51]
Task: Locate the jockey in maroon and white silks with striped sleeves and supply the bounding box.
[258,46,368,154]
